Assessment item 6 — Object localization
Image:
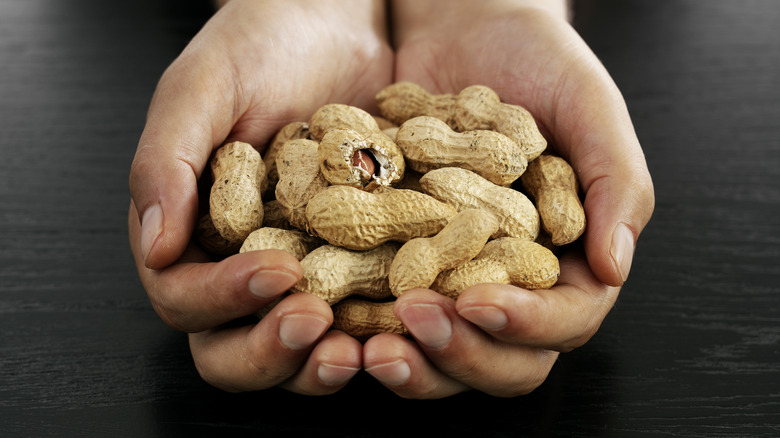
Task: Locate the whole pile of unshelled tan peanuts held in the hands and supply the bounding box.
[195,82,585,339]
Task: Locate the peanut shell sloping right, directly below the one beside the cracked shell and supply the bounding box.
[420,167,539,240]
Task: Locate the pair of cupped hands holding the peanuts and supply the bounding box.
[128,0,654,398]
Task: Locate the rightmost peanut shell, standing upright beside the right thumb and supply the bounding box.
[521,155,586,246]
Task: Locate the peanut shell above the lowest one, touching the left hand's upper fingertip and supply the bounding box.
[292,242,399,305]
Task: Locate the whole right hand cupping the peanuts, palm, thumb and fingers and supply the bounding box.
[363,0,654,398]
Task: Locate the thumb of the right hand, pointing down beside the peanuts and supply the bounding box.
[545,36,655,286]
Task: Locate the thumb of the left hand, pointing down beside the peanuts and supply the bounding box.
[129,58,233,269]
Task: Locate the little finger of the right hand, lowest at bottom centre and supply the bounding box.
[363,333,470,399]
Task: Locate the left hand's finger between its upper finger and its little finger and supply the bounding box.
[189,294,333,392]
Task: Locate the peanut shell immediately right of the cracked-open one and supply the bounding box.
[396,116,528,185]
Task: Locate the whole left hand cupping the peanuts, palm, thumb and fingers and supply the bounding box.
[128,0,393,394]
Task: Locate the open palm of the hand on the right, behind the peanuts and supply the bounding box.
[396,12,576,156]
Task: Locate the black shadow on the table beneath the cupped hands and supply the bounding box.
[146,332,616,437]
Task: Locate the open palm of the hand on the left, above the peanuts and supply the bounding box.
[185,4,393,151]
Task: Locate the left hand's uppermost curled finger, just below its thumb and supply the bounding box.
[128,203,302,332]
